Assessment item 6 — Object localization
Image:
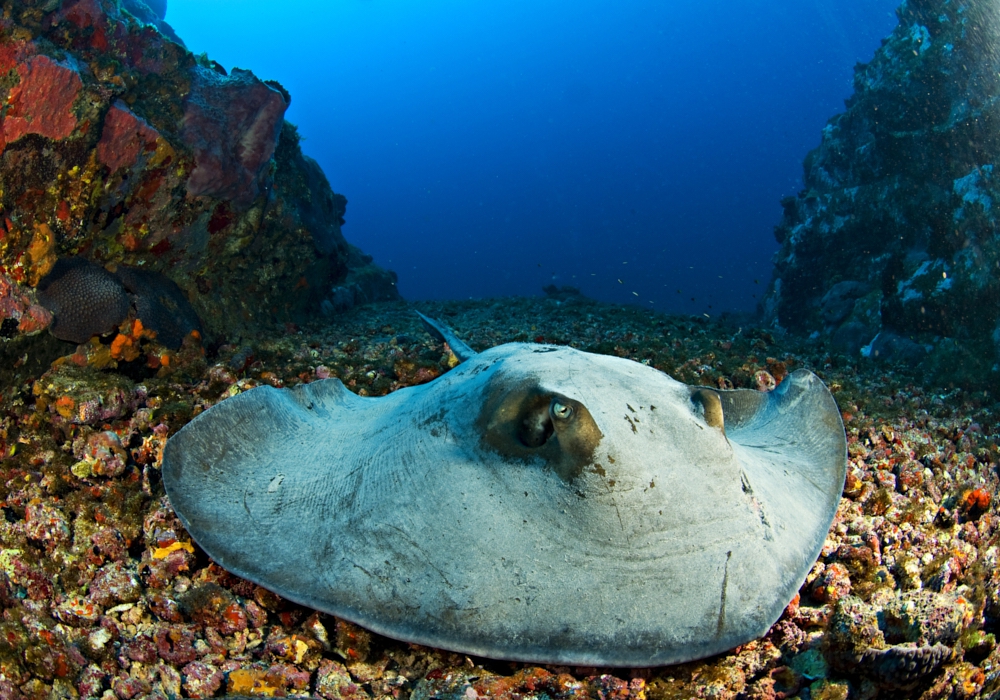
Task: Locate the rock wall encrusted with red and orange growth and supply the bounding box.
[0,0,398,348]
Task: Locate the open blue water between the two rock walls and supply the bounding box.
[167,0,896,315]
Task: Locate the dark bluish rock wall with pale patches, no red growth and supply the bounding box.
[763,0,1000,382]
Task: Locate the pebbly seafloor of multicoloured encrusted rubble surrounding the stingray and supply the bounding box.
[0,296,1000,700]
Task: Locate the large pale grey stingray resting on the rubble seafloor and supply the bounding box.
[163,314,846,667]
